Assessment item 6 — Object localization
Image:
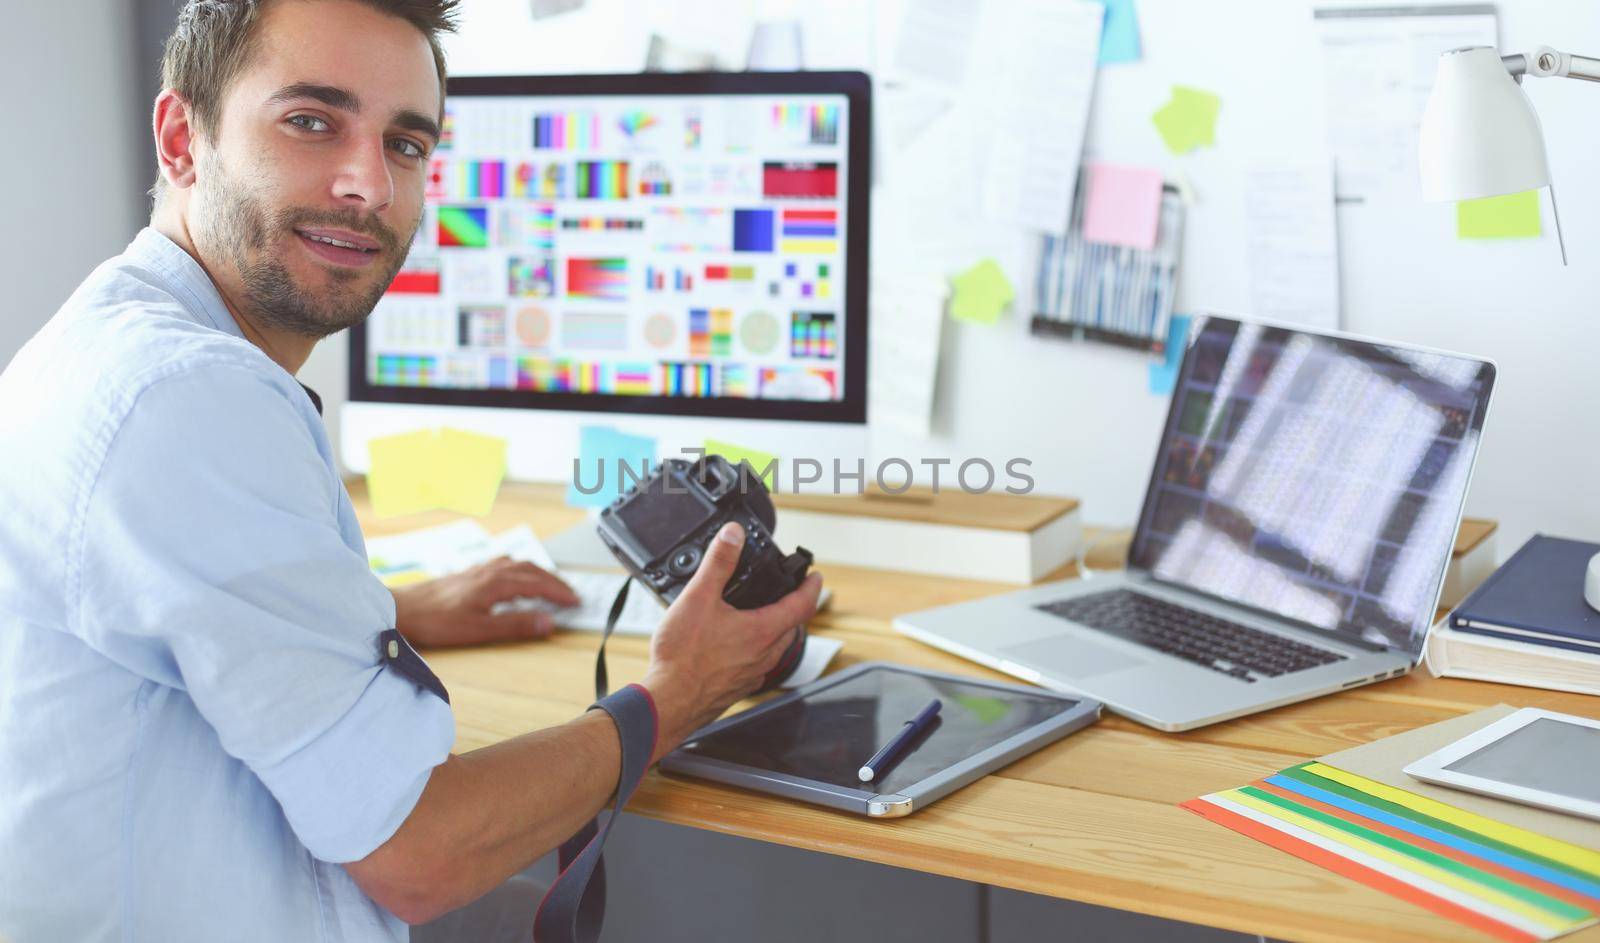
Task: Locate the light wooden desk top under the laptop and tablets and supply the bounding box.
[350,482,1600,943]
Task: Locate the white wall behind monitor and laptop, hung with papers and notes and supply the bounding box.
[412,0,1600,554]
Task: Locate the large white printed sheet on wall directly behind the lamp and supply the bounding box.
[1315,3,1498,202]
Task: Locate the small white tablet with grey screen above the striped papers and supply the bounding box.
[1405,708,1600,818]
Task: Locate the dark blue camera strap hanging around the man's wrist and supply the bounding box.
[533,580,646,943]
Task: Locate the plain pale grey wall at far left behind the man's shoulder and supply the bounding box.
[0,0,149,365]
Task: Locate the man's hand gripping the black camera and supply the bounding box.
[645,524,822,759]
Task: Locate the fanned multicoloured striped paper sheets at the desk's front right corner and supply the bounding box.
[1182,751,1600,941]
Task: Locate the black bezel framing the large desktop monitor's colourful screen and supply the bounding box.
[347,72,872,424]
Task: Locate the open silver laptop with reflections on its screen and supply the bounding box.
[894,317,1494,730]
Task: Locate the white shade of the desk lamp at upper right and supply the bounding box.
[1418,46,1550,200]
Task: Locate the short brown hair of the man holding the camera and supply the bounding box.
[152,0,459,194]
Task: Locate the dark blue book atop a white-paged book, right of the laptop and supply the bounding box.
[1427,535,1600,695]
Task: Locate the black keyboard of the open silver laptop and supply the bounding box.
[1038,589,1346,682]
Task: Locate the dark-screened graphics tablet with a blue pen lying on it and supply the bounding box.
[661,661,1101,818]
